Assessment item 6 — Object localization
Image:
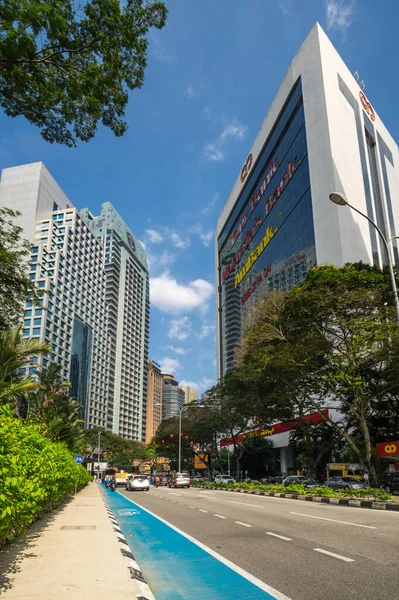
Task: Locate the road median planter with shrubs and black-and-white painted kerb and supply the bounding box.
[191,482,399,512]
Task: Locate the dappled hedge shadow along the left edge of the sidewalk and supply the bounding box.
[0,497,72,596]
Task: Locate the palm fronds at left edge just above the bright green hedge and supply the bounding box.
[0,326,51,404]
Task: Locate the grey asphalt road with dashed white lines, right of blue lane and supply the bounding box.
[118,487,399,600]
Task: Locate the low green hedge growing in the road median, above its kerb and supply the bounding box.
[191,481,392,502]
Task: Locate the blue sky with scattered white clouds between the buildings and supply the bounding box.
[0,0,399,392]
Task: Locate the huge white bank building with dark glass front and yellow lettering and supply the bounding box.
[216,24,399,377]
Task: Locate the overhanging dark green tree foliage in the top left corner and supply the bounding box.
[0,0,167,146]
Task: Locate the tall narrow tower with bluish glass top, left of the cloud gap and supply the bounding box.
[81,202,150,441]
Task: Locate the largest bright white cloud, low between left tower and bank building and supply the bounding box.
[150,271,214,313]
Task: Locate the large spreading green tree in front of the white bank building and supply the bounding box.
[238,263,399,483]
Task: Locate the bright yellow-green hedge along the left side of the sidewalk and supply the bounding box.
[0,406,91,541]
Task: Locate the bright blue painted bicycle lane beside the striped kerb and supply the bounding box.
[102,489,289,600]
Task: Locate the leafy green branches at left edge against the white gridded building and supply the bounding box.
[0,208,37,331]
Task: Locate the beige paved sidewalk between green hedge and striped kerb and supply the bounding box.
[0,483,144,600]
